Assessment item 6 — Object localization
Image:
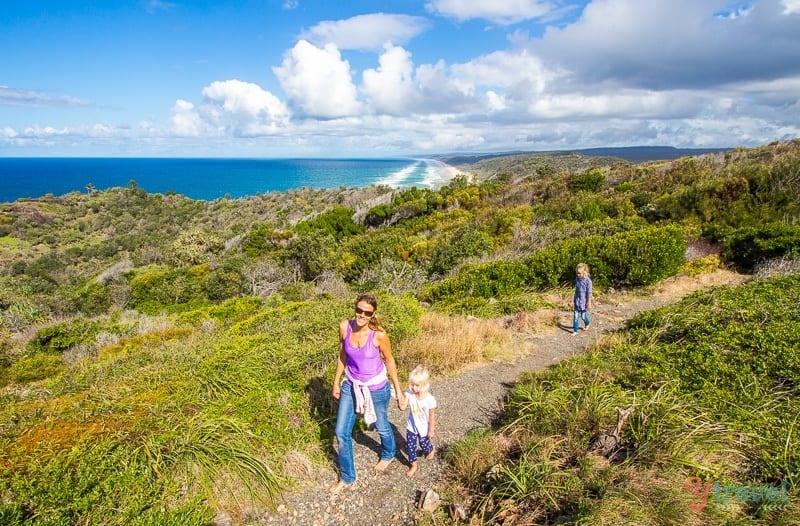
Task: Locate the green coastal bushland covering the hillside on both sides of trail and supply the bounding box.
[0,141,800,524]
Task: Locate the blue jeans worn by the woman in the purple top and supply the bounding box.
[336,382,396,484]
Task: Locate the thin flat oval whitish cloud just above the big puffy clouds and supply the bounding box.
[300,13,430,51]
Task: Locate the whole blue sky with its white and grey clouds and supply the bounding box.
[0,0,800,157]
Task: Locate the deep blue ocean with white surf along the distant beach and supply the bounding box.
[0,157,451,202]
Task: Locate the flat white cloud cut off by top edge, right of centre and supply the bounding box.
[425,0,554,25]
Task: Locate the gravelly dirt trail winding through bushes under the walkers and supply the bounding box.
[255,271,746,526]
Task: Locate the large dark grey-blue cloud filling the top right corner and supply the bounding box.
[530,0,800,89]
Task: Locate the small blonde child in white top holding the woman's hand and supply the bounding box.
[406,365,436,477]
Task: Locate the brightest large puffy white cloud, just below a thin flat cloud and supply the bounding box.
[272,40,360,119]
